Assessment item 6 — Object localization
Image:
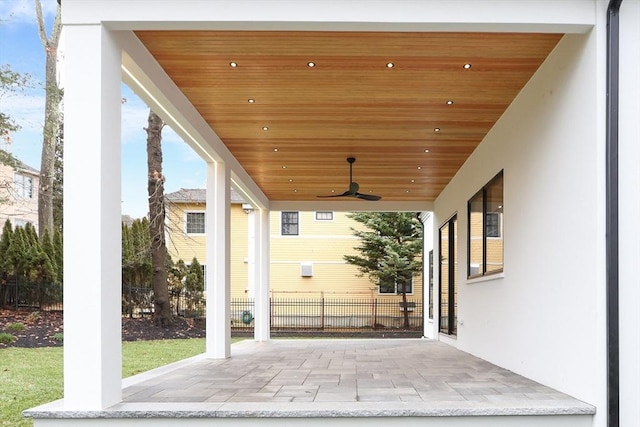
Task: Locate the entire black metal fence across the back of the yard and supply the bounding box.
[0,280,423,332]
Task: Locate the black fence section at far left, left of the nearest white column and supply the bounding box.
[0,278,62,311]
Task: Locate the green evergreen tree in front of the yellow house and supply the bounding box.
[344,212,422,328]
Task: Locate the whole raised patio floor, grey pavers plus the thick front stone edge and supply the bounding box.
[29,339,595,425]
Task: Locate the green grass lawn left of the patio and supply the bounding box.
[0,338,212,427]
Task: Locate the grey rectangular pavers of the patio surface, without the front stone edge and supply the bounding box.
[116,339,588,416]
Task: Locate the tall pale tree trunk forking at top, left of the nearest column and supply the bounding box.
[35,0,62,236]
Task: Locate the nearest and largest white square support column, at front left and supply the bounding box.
[64,25,122,410]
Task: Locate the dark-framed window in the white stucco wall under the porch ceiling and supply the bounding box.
[467,171,504,278]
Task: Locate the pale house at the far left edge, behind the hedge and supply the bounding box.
[0,150,40,230]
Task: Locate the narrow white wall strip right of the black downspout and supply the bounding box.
[619,0,640,426]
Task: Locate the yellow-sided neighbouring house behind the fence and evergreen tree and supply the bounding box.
[165,188,422,301]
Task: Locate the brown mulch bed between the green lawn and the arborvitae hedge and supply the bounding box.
[0,309,205,348]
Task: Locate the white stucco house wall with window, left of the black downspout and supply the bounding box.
[435,30,606,418]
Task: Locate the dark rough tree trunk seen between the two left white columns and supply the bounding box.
[146,111,173,326]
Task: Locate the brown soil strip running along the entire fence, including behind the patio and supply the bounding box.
[0,309,422,348]
